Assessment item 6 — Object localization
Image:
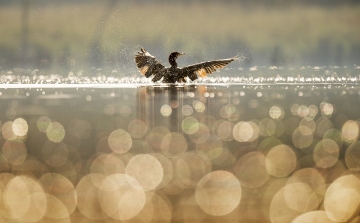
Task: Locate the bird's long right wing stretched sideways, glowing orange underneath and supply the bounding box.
[180,56,239,81]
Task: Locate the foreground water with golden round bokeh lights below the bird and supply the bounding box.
[0,85,360,223]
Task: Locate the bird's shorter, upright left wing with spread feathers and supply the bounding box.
[135,48,165,82]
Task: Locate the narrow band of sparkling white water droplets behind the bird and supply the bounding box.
[0,65,360,88]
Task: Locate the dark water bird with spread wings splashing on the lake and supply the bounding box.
[135,48,239,83]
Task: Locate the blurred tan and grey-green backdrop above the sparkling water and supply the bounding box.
[0,0,360,72]
